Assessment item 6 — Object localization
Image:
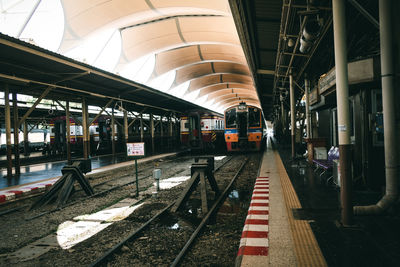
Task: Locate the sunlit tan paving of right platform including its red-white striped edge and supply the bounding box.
[236,141,327,267]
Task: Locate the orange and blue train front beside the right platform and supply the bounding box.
[224,102,265,151]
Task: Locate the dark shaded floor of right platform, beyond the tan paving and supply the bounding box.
[276,140,400,266]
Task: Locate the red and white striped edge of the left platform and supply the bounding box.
[0,177,59,203]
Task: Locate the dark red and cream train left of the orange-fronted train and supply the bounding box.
[180,110,224,151]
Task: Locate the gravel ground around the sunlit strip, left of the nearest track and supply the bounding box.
[0,154,233,266]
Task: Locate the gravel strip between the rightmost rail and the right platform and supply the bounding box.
[181,154,262,266]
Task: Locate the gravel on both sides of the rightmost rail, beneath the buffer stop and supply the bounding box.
[97,155,259,266]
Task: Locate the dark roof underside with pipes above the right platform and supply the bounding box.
[229,0,379,120]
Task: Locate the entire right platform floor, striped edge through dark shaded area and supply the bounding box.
[236,140,400,266]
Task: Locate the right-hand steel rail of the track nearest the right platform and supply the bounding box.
[170,158,248,267]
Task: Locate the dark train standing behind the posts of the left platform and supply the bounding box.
[47,115,179,155]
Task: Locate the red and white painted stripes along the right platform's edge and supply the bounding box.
[237,177,269,262]
